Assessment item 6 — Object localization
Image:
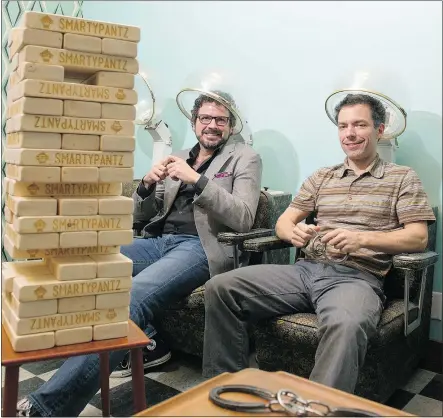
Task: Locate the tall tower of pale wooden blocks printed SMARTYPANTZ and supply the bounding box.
[2,12,140,351]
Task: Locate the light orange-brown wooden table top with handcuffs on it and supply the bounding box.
[135,369,413,417]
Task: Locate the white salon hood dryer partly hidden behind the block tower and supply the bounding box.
[135,71,172,164]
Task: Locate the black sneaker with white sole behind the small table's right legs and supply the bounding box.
[111,336,171,377]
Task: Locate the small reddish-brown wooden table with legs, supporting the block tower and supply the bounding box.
[2,321,149,417]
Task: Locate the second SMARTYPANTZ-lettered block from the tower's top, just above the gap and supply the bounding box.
[18,45,138,75]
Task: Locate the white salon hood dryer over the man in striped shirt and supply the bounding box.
[325,68,409,163]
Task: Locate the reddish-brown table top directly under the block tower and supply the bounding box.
[2,320,149,366]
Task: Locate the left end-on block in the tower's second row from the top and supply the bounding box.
[9,27,62,57]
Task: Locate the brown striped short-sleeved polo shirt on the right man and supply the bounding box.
[290,154,435,278]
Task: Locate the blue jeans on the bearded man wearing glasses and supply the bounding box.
[28,235,209,416]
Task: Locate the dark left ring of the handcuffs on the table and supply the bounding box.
[209,385,275,412]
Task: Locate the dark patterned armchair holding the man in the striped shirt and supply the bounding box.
[242,208,438,402]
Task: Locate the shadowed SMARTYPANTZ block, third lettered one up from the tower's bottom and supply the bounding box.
[3,232,120,260]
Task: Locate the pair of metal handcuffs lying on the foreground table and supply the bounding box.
[209,385,381,417]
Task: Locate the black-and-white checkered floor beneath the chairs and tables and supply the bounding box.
[2,354,443,417]
